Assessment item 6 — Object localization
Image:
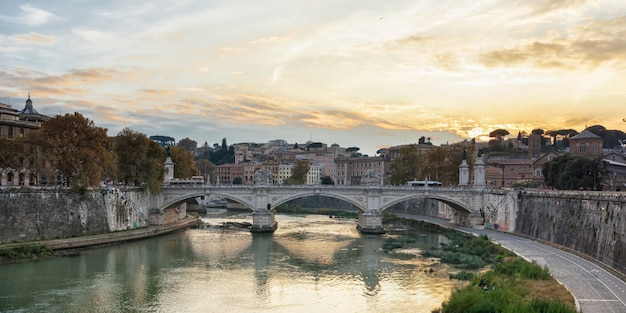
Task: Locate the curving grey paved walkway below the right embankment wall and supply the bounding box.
[395,213,626,313]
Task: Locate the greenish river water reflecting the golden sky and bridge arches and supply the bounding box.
[0,210,458,313]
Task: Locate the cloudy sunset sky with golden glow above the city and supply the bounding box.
[0,0,626,155]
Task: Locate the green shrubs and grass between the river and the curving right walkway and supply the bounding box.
[383,214,576,313]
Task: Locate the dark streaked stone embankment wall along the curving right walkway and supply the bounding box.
[515,192,626,273]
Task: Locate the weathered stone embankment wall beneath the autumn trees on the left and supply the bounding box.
[0,189,149,243]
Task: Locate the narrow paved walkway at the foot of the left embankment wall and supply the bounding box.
[0,217,198,250]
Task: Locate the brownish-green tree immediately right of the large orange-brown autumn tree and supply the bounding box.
[114,128,166,193]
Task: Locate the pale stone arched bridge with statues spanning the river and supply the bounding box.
[150,179,517,233]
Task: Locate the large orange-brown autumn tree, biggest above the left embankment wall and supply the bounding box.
[40,112,115,191]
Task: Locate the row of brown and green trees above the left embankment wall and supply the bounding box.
[0,112,198,193]
